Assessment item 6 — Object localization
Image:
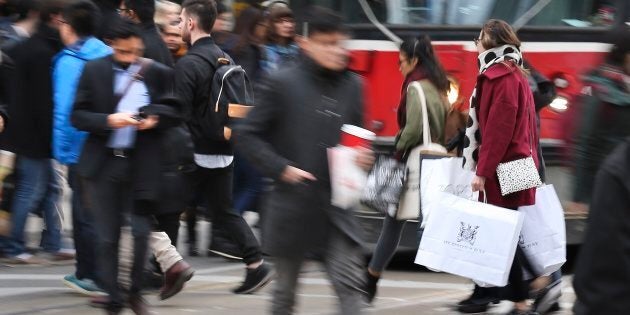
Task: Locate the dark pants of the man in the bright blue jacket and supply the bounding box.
[68,165,100,283]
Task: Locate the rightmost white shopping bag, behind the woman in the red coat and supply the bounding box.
[518,185,567,276]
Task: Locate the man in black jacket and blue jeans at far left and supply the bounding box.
[1,0,74,263]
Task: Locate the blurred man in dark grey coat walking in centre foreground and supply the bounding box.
[235,7,374,315]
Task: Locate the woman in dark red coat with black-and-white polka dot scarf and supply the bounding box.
[464,20,538,315]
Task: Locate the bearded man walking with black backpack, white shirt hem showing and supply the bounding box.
[175,0,273,294]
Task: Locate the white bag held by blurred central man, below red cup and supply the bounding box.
[328,146,368,209]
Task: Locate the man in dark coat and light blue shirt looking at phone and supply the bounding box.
[71,21,179,314]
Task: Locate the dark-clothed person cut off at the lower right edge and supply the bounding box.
[573,138,630,315]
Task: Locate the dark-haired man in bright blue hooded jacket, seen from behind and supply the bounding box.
[53,0,111,296]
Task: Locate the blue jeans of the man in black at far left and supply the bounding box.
[6,156,61,256]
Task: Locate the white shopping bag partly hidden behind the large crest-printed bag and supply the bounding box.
[420,157,479,228]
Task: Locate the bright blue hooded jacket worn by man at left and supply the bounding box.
[53,37,111,164]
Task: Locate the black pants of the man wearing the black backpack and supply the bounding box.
[193,165,262,264]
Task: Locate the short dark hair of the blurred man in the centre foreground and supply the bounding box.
[297,6,348,36]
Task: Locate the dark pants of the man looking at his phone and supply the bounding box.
[88,155,151,311]
